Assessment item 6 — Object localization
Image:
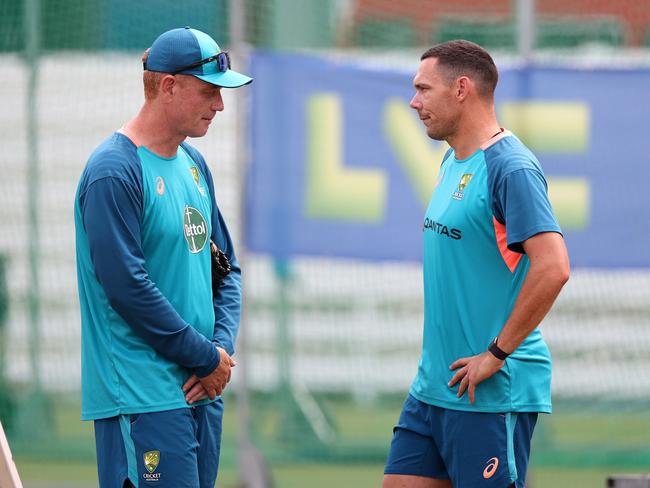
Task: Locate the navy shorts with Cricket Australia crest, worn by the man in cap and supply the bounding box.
[95,398,223,488]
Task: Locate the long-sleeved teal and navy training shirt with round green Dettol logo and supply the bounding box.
[75,133,241,420]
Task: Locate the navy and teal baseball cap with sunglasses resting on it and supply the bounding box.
[144,27,253,88]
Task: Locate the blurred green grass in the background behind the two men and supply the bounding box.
[11,396,650,488]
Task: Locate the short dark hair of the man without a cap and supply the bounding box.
[420,39,499,97]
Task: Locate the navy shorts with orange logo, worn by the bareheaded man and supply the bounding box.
[384,395,537,488]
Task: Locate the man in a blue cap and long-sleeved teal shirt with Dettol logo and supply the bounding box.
[75,27,252,488]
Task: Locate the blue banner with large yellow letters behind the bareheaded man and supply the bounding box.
[246,52,650,267]
